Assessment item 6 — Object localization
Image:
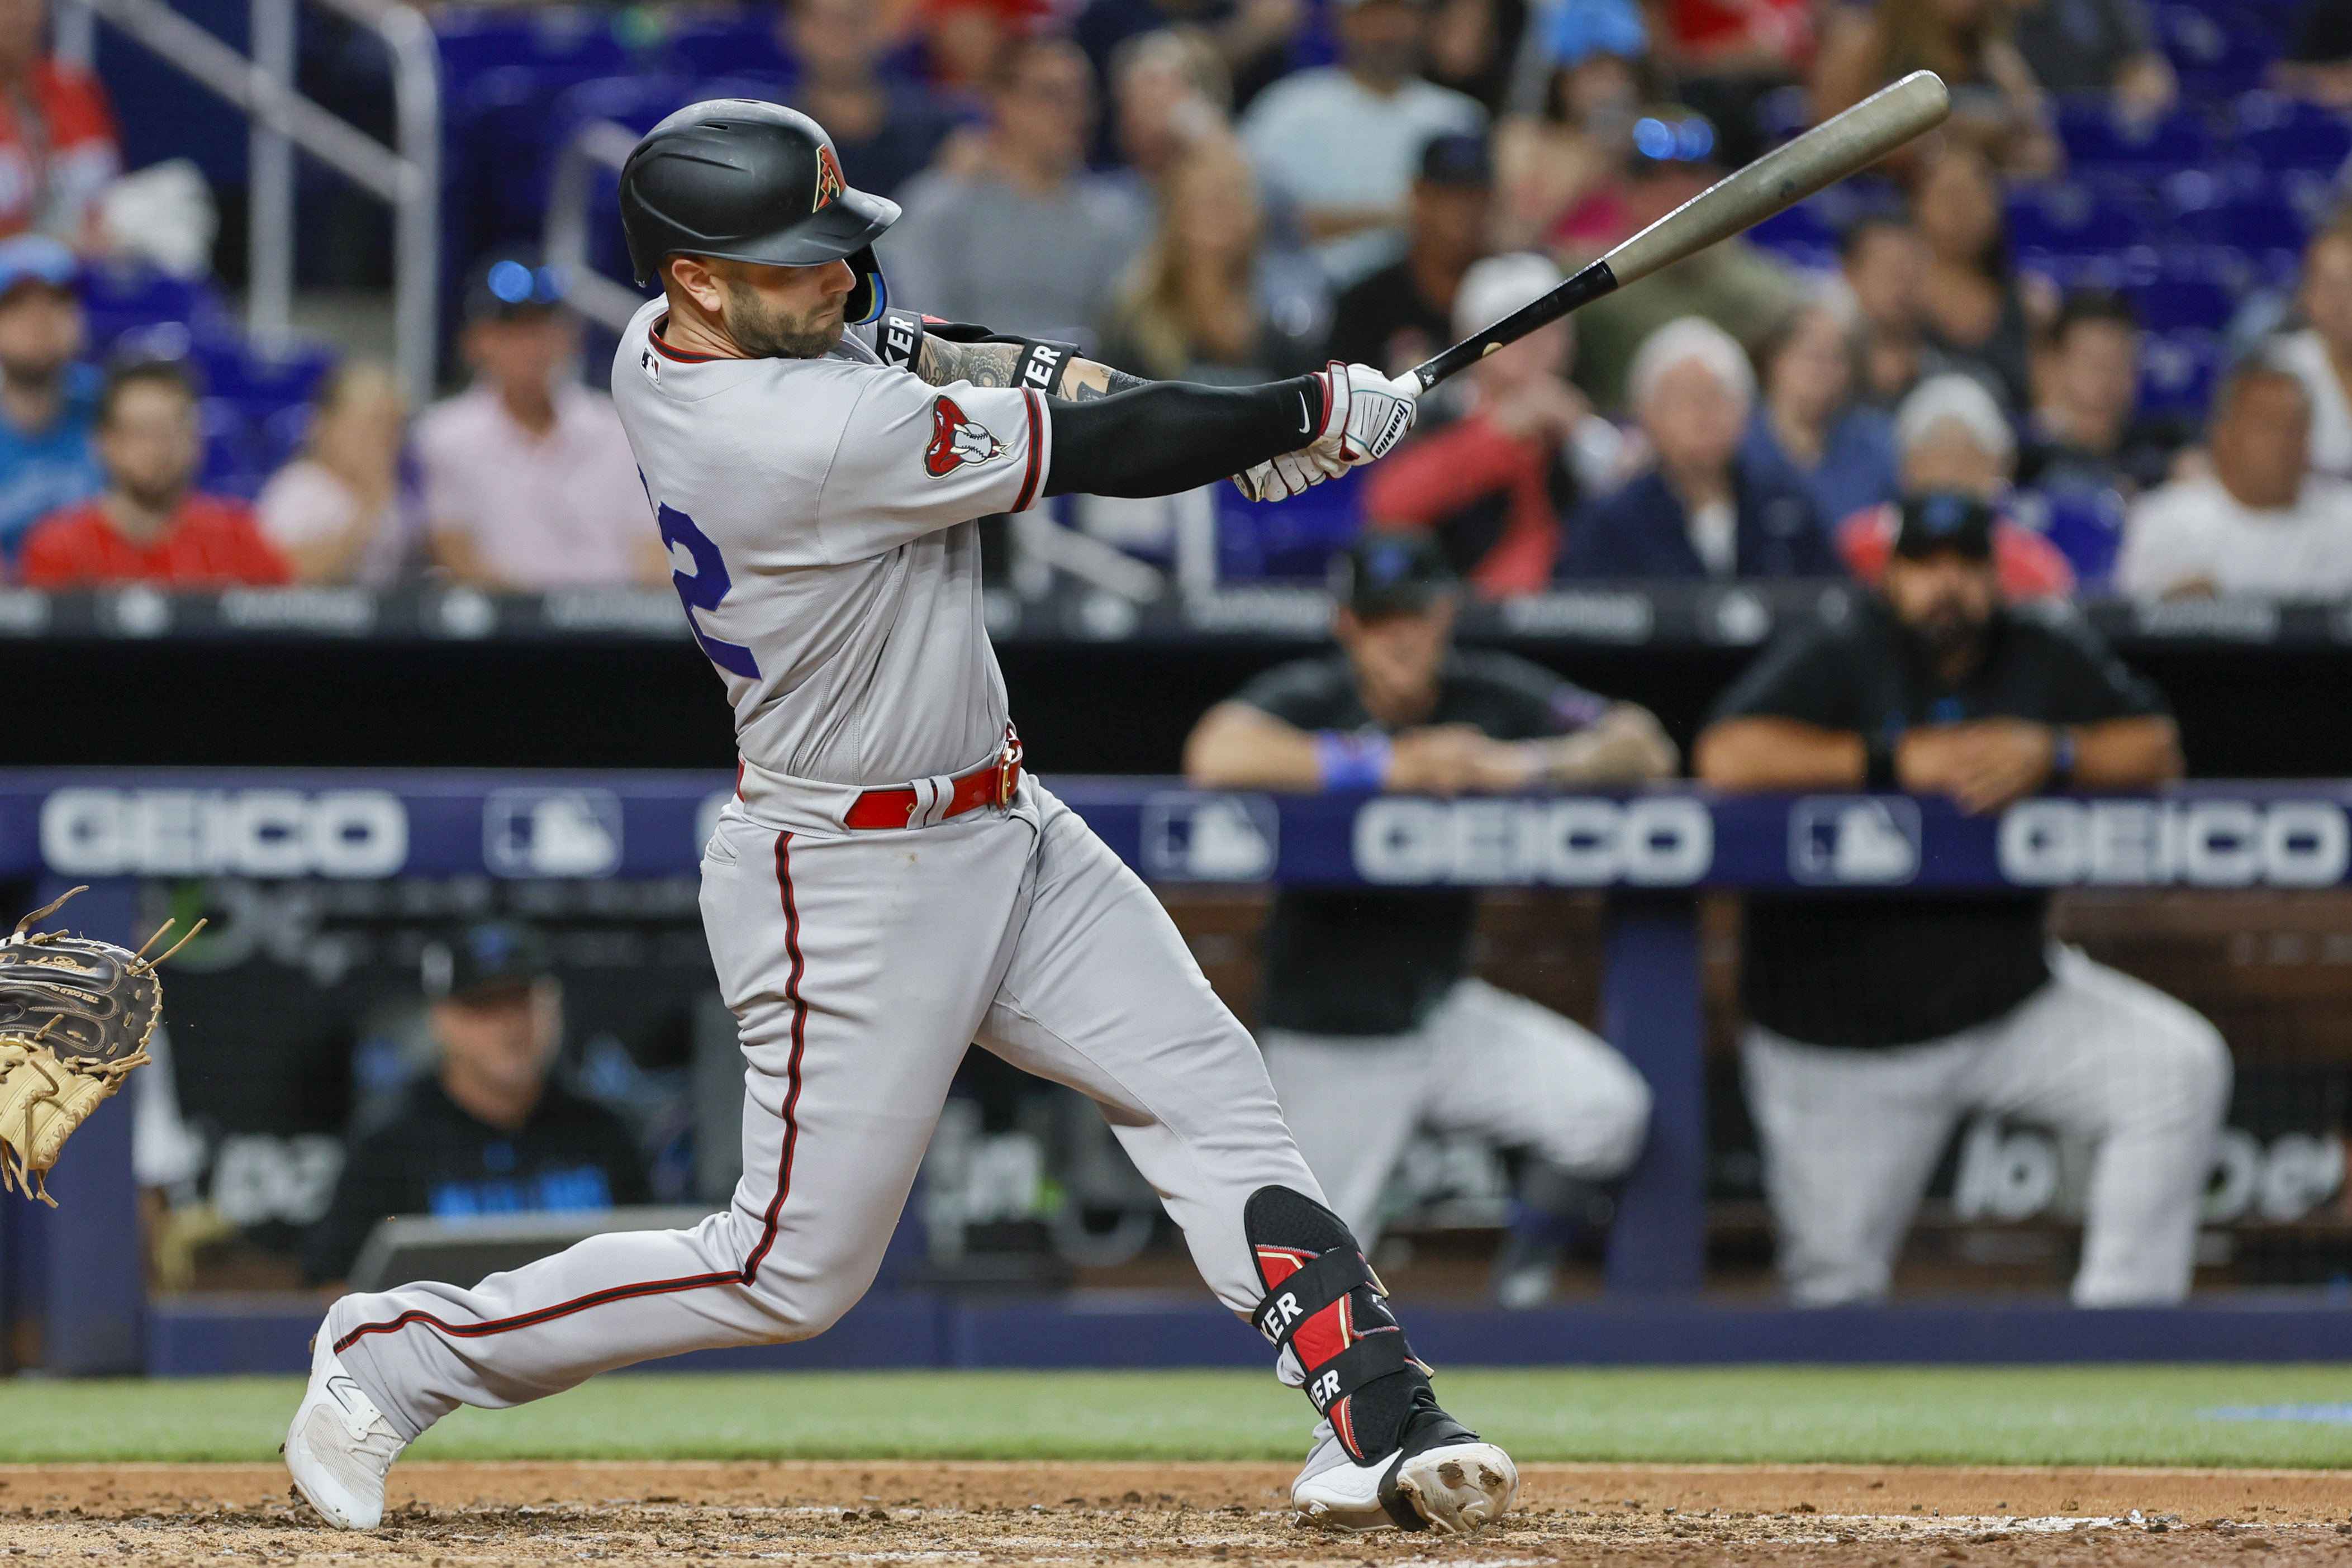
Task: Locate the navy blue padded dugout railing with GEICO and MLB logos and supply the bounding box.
[0,769,2352,1373]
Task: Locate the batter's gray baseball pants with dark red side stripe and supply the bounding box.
[325,778,1322,1439]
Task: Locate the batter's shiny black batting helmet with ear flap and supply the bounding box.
[621,99,899,322]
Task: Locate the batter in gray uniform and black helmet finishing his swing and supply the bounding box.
[287,99,1519,1531]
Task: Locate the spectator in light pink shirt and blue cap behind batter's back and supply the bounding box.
[416,254,668,592]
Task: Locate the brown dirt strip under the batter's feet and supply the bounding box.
[0,1462,2352,1568]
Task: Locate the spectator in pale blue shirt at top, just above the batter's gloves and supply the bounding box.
[1242,0,1486,286]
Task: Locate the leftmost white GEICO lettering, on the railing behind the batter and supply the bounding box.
[40,790,409,877]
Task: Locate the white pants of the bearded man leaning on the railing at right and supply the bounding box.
[1741,947,2230,1307]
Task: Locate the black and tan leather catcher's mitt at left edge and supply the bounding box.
[0,888,205,1208]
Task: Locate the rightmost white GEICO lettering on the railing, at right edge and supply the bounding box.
[1999,799,2352,886]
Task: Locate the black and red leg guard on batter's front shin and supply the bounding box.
[1242,1187,1477,1531]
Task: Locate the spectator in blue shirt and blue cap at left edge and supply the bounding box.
[0,235,106,564]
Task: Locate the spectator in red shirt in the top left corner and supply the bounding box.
[0,0,122,251]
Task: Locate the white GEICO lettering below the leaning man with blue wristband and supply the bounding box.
[1355,797,1714,886]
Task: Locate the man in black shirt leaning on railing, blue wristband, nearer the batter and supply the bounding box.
[1185,531,1675,1307]
